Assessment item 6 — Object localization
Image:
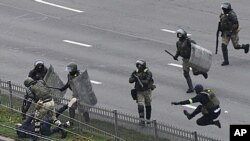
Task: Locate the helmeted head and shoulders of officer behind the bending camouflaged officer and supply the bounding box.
[28,60,48,80]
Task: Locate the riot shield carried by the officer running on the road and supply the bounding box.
[189,43,212,72]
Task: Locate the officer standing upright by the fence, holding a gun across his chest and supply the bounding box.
[129,60,155,125]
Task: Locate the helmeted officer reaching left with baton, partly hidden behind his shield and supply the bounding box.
[60,62,90,125]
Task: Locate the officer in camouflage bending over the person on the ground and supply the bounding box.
[24,78,65,140]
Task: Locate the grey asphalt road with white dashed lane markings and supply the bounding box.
[0,0,250,140]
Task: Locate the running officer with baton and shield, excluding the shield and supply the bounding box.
[173,29,208,93]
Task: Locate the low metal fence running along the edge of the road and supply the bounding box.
[0,80,222,141]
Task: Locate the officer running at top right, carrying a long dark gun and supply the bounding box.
[219,2,249,66]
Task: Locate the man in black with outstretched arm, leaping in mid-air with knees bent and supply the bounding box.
[171,84,221,128]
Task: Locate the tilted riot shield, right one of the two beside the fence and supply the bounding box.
[69,70,97,106]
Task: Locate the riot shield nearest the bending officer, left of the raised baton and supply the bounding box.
[44,65,66,103]
